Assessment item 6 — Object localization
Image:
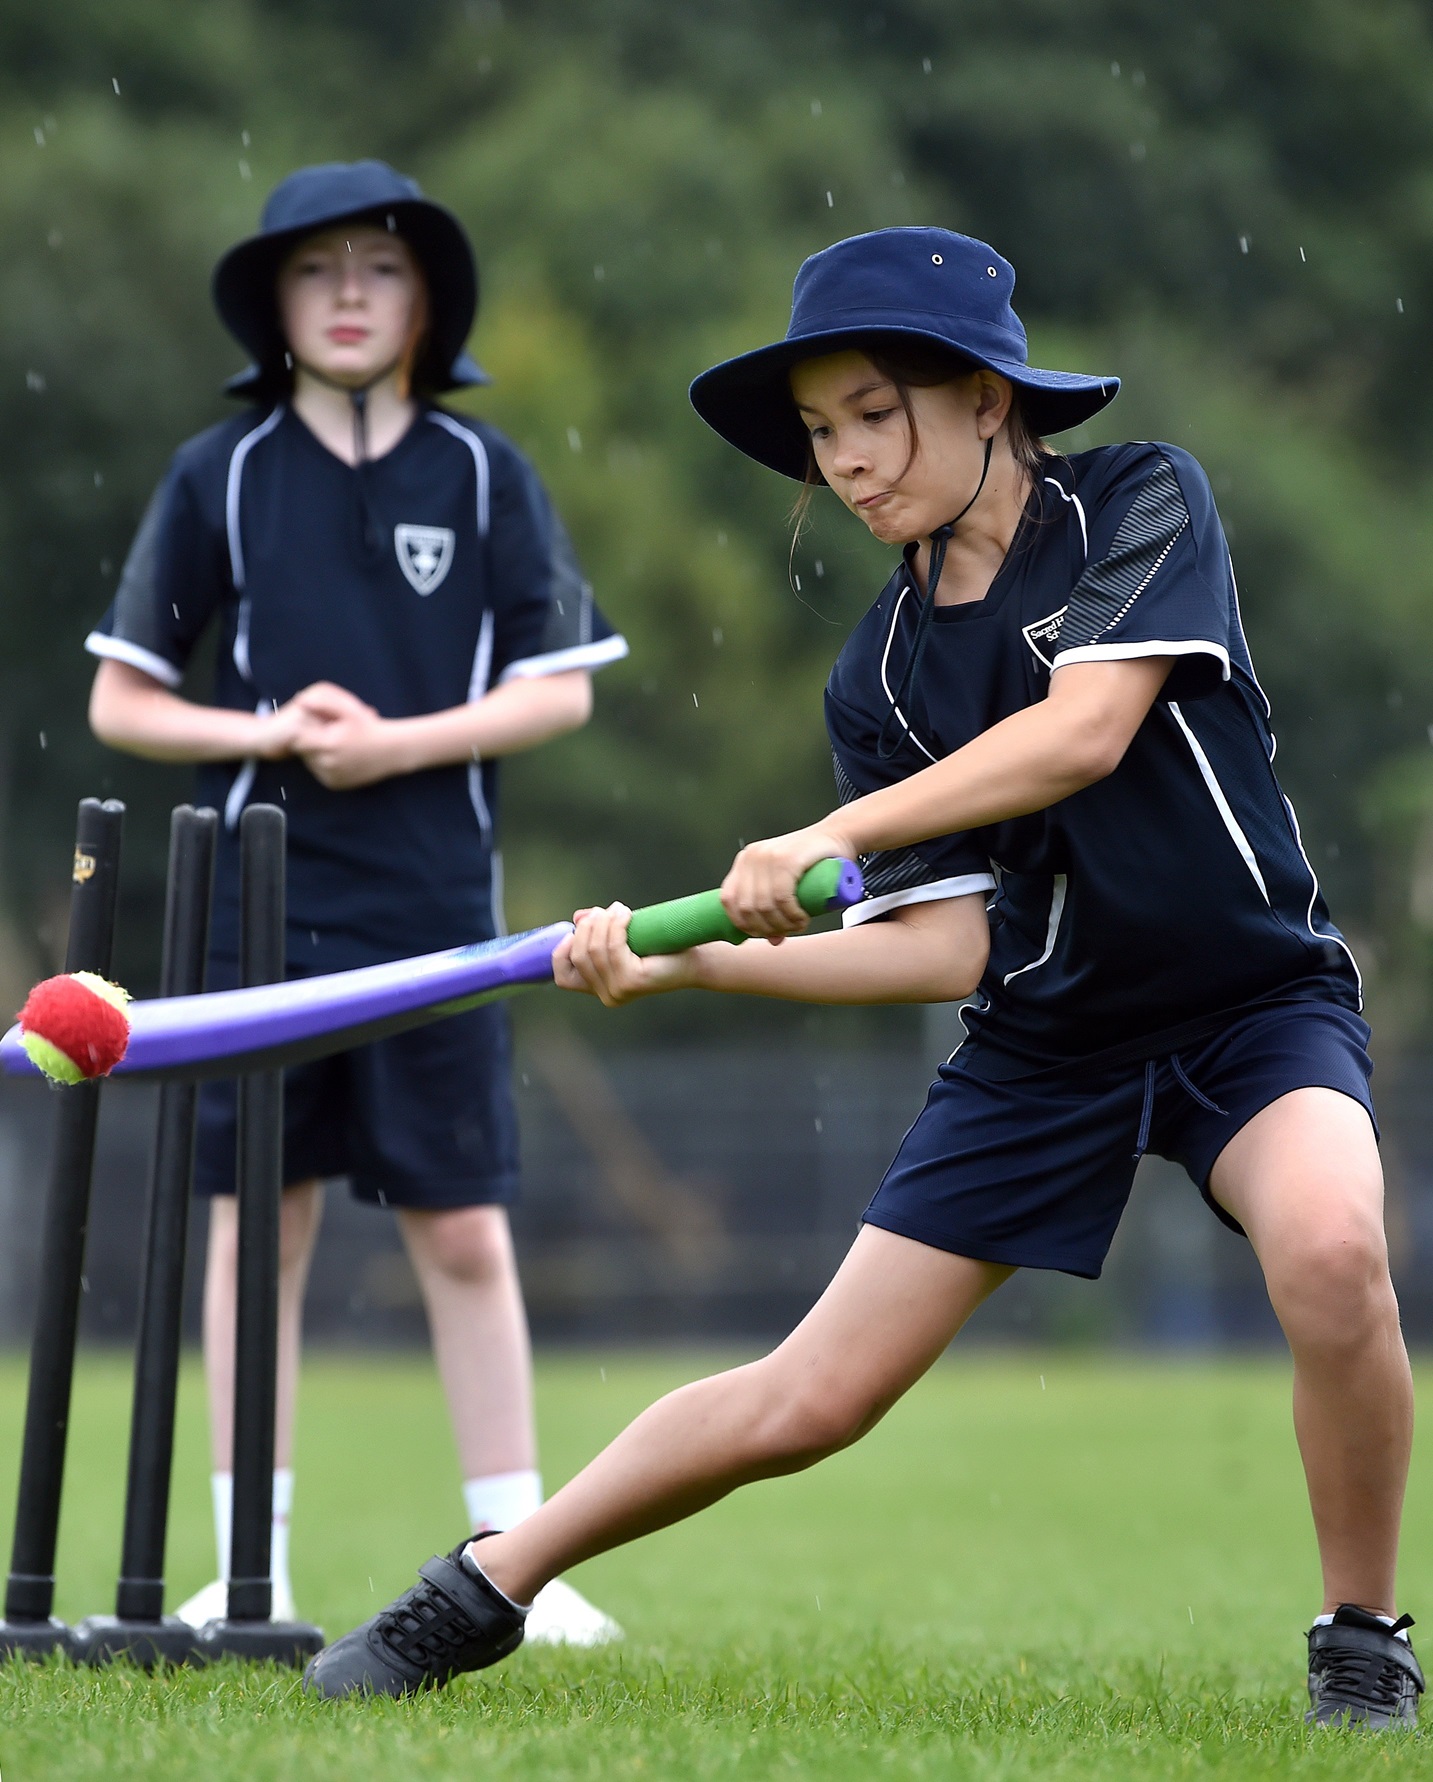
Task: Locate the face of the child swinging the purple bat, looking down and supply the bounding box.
[791,351,1011,545]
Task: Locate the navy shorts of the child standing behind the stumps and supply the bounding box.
[194,960,519,1212]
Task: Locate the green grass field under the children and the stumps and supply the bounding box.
[0,1351,1433,1782]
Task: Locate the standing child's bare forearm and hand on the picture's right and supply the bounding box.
[294,668,592,789]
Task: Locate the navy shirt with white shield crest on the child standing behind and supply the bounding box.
[87,405,627,969]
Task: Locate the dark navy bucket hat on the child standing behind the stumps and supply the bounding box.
[214,160,490,401]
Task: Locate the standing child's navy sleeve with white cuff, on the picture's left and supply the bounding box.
[86,465,228,688]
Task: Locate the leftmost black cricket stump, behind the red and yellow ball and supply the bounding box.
[0,798,125,1657]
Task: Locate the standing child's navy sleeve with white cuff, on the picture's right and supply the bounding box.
[490,447,627,684]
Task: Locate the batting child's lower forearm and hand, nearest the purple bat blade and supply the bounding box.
[553,896,991,1009]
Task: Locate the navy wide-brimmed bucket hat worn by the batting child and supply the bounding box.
[690,228,1119,483]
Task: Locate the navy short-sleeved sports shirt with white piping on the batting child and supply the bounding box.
[825,444,1362,1076]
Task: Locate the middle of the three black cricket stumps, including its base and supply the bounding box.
[71,804,219,1670]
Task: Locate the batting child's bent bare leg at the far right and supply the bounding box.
[1210,1089,1413,1614]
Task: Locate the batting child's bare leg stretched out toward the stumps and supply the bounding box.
[474,1226,1014,1602]
